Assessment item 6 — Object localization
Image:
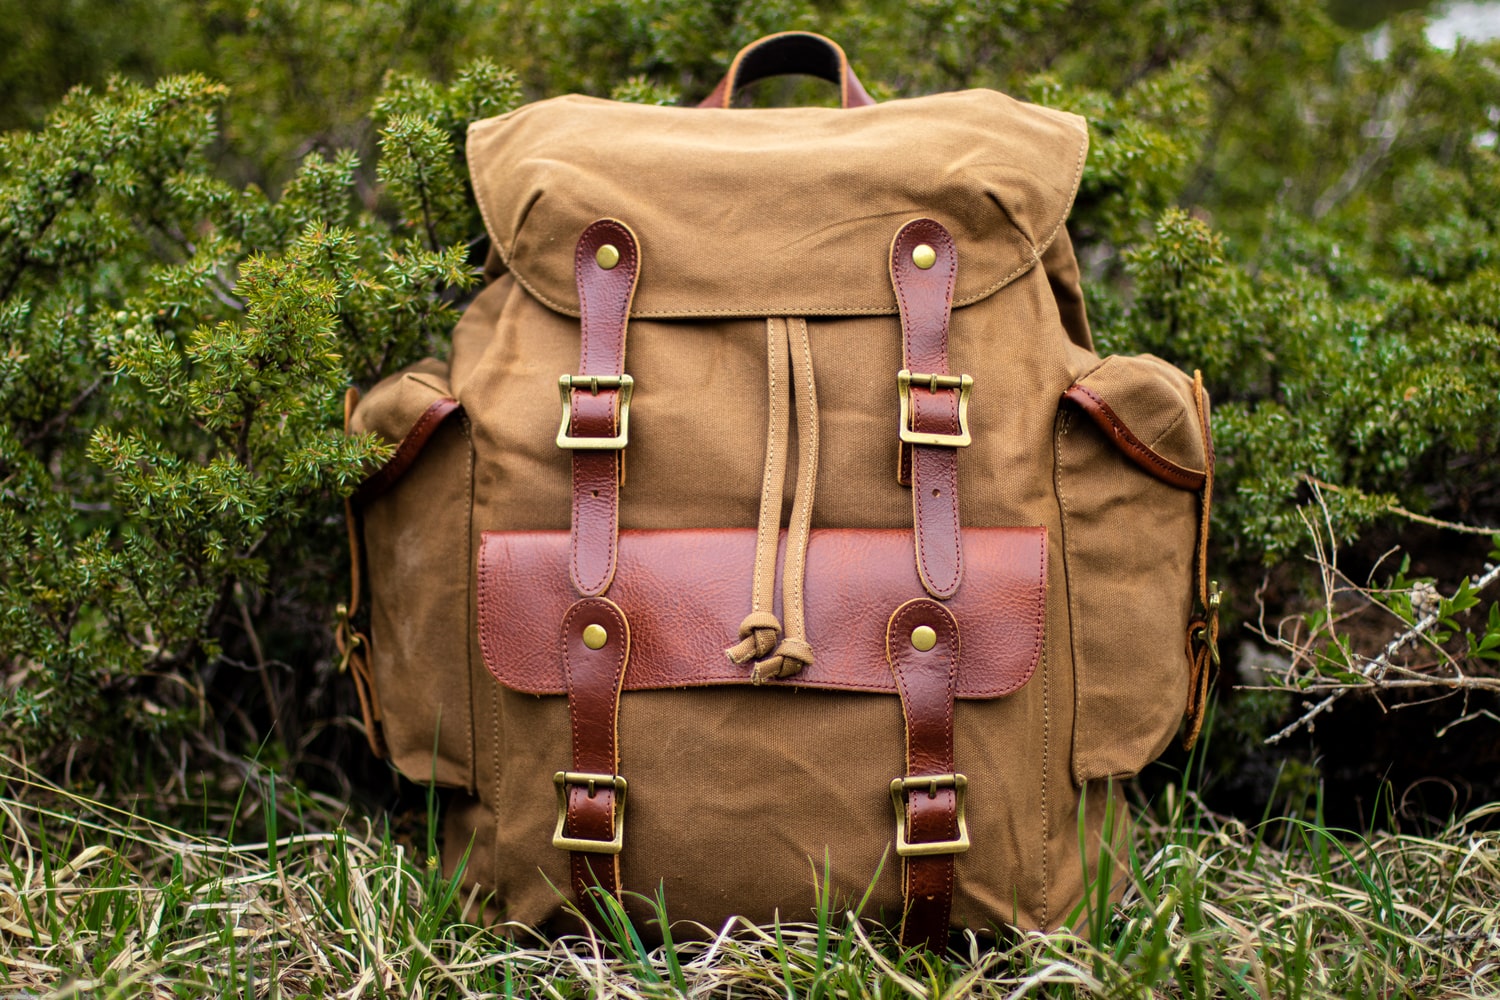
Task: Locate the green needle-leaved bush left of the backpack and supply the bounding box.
[0,63,516,768]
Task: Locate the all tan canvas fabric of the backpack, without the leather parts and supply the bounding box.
[345,66,1206,930]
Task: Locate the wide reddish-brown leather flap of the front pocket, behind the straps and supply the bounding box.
[479,528,1047,699]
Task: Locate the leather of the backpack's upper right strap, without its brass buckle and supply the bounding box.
[891,219,963,600]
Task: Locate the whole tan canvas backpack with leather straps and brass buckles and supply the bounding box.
[341,33,1217,946]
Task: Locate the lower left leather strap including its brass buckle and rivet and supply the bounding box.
[552,597,630,916]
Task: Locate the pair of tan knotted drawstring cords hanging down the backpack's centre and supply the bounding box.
[726,319,818,684]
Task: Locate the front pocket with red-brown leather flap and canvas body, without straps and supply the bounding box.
[474,526,1050,924]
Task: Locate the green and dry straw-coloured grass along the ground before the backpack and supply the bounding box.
[0,759,1500,1000]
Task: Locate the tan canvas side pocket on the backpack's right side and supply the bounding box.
[1056,355,1212,784]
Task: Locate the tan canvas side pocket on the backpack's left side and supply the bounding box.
[350,358,474,787]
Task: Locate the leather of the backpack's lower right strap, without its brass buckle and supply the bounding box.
[887,598,960,955]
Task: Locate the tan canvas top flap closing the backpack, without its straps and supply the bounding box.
[468,90,1088,318]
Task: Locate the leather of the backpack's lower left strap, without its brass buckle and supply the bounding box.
[563,597,630,913]
